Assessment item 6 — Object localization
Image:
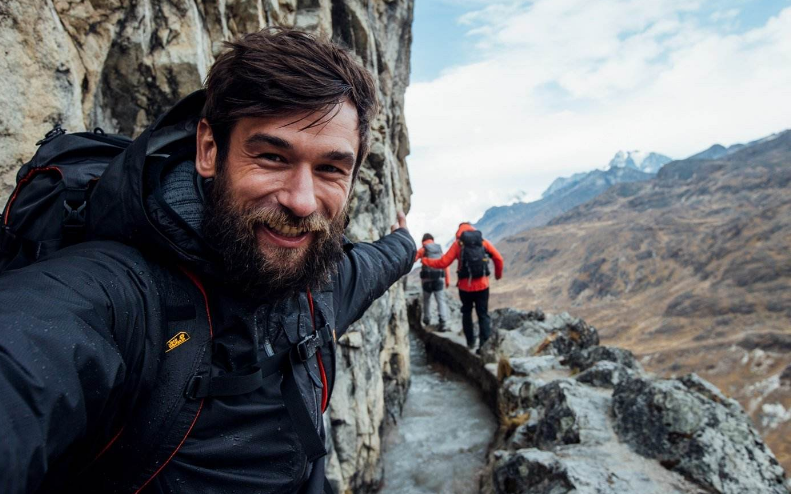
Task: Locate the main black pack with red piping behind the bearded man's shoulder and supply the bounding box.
[0,125,132,272]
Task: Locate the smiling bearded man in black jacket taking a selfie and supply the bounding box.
[0,29,416,494]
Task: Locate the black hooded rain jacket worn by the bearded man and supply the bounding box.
[0,93,416,494]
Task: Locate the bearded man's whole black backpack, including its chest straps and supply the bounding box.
[0,117,335,492]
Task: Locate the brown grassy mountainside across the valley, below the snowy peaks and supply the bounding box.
[490,131,791,471]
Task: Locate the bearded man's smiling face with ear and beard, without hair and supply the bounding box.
[196,101,360,292]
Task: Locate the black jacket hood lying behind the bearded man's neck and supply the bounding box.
[87,90,211,268]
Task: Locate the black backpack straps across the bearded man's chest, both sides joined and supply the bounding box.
[80,268,335,493]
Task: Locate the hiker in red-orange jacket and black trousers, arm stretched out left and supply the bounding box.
[422,222,503,352]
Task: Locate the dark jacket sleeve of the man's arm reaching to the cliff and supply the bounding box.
[333,228,417,337]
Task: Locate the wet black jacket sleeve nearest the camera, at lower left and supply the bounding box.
[0,243,159,494]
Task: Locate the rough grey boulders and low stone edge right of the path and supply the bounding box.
[409,297,791,494]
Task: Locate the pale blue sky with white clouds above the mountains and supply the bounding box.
[405,0,791,243]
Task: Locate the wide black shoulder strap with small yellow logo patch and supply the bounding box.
[77,263,213,493]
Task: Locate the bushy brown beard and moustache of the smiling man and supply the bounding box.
[202,171,348,298]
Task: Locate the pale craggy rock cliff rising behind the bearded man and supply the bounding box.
[0,0,413,492]
